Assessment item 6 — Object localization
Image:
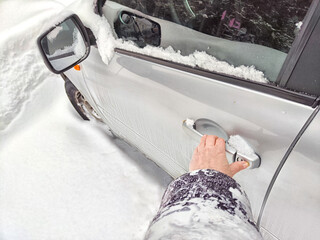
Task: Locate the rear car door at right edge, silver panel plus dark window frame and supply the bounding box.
[259,5,320,240]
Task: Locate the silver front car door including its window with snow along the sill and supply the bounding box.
[72,1,318,238]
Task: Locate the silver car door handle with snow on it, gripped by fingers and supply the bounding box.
[182,118,261,169]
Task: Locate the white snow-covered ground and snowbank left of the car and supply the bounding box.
[0,0,171,240]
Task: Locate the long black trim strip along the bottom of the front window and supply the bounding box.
[115,48,316,106]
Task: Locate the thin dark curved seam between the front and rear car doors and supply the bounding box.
[257,105,320,228]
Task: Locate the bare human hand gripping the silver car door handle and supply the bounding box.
[189,135,249,177]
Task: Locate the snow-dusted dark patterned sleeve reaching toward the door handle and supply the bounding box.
[145,169,262,240]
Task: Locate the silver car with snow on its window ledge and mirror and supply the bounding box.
[38,0,320,240]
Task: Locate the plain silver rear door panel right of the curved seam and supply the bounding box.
[261,109,320,239]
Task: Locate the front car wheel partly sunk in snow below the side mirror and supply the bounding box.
[64,80,102,122]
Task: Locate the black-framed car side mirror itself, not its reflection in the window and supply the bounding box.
[37,14,90,74]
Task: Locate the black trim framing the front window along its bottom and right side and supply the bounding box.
[95,0,320,108]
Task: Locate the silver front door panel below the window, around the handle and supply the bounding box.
[71,46,313,221]
